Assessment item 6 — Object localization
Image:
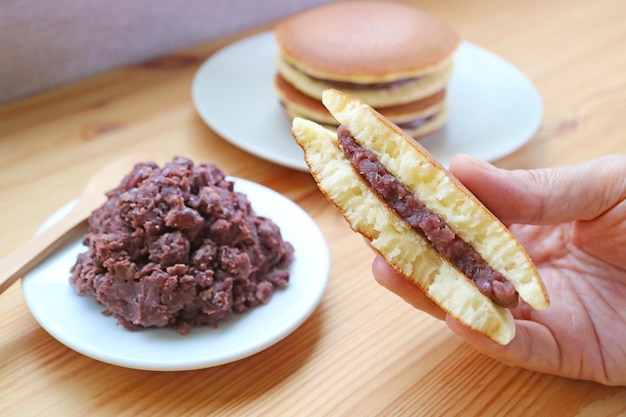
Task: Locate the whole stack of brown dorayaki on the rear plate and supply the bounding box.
[274,1,460,138]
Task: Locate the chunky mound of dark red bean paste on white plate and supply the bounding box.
[70,157,294,334]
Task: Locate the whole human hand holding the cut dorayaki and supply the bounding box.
[372,155,626,385]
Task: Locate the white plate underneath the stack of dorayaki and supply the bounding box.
[191,32,543,171]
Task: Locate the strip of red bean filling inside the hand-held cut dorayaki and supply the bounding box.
[337,125,519,308]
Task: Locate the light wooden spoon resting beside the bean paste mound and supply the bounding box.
[0,155,162,294]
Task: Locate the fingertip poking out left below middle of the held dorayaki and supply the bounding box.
[372,256,445,320]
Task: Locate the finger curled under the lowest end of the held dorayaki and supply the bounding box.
[446,316,563,375]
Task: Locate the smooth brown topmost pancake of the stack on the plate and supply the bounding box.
[274,1,460,83]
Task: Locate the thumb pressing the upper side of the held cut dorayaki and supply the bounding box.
[450,155,626,224]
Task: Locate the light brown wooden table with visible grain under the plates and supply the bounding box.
[0,0,626,416]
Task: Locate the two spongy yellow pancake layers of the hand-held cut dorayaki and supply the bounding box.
[292,90,549,344]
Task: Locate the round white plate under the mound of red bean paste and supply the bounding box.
[22,178,330,371]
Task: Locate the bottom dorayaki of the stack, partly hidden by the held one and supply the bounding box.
[274,74,447,138]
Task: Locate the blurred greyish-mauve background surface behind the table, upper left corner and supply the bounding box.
[0,0,330,104]
